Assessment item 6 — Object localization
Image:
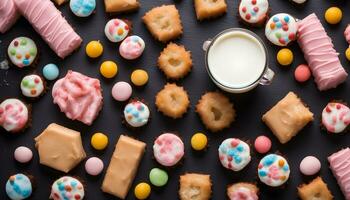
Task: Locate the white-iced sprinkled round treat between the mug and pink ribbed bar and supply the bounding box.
[265,13,298,46]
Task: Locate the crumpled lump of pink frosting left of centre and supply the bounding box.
[52,70,103,125]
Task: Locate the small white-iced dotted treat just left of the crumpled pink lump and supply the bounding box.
[21,74,45,98]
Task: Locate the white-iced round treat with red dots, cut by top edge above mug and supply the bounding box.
[238,0,269,26]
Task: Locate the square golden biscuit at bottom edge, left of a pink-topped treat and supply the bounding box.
[179,173,211,200]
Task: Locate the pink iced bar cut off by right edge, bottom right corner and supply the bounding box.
[328,147,350,200]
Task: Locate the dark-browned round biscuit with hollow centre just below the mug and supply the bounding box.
[196,92,236,132]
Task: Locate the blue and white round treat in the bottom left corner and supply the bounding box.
[6,174,33,200]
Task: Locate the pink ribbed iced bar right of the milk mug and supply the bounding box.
[298,14,348,91]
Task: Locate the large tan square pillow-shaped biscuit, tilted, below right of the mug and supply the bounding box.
[262,92,313,144]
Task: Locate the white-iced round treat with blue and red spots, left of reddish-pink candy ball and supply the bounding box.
[218,138,251,171]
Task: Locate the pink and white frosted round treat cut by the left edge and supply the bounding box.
[0,99,29,132]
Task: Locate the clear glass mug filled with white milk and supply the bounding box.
[203,28,275,93]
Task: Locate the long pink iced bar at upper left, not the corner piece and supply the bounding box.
[15,0,82,58]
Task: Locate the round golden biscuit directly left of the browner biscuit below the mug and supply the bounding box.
[155,83,190,119]
